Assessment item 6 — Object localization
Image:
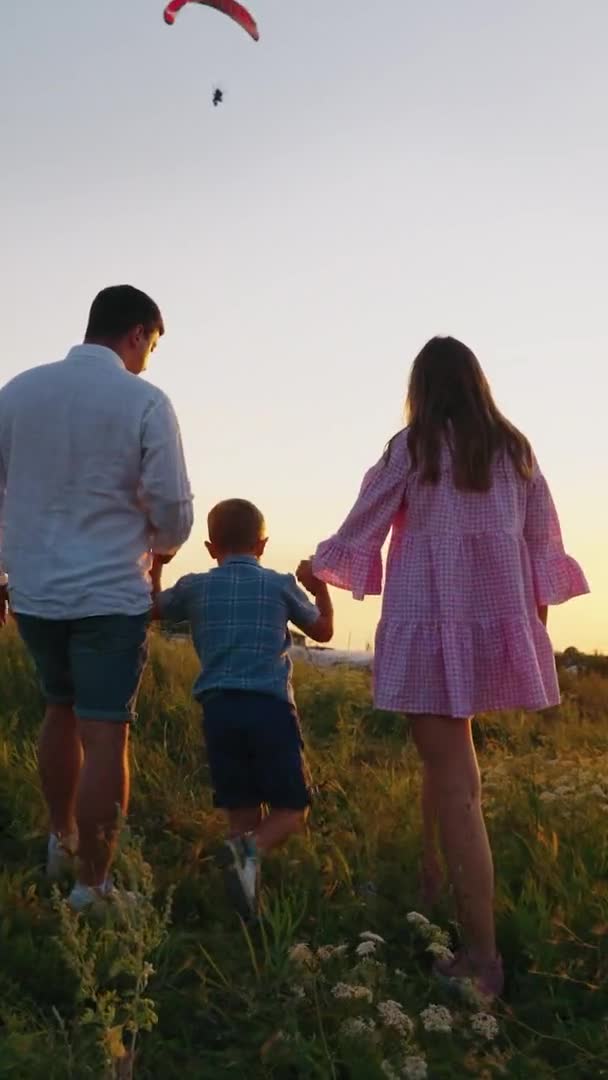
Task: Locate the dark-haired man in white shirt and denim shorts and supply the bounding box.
[0,285,192,909]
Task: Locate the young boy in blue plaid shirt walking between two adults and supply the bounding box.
[156,499,334,918]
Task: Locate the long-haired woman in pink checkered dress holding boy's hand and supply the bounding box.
[299,337,589,995]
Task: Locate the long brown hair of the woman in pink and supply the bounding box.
[397,337,532,491]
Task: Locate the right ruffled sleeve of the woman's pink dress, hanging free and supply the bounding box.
[524,461,590,607]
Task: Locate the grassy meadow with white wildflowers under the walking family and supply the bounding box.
[0,631,608,1080]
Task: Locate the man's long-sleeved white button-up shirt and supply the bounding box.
[0,345,192,619]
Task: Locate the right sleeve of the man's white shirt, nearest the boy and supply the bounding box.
[139,394,192,555]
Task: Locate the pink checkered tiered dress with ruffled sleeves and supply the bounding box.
[313,431,589,716]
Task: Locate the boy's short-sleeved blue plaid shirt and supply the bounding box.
[158,555,319,702]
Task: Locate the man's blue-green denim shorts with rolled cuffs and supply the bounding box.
[15,612,150,724]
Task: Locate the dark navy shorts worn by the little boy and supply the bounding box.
[201,690,310,810]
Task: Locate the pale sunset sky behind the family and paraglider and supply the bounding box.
[0,0,608,651]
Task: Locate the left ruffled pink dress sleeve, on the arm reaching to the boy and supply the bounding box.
[312,432,408,600]
